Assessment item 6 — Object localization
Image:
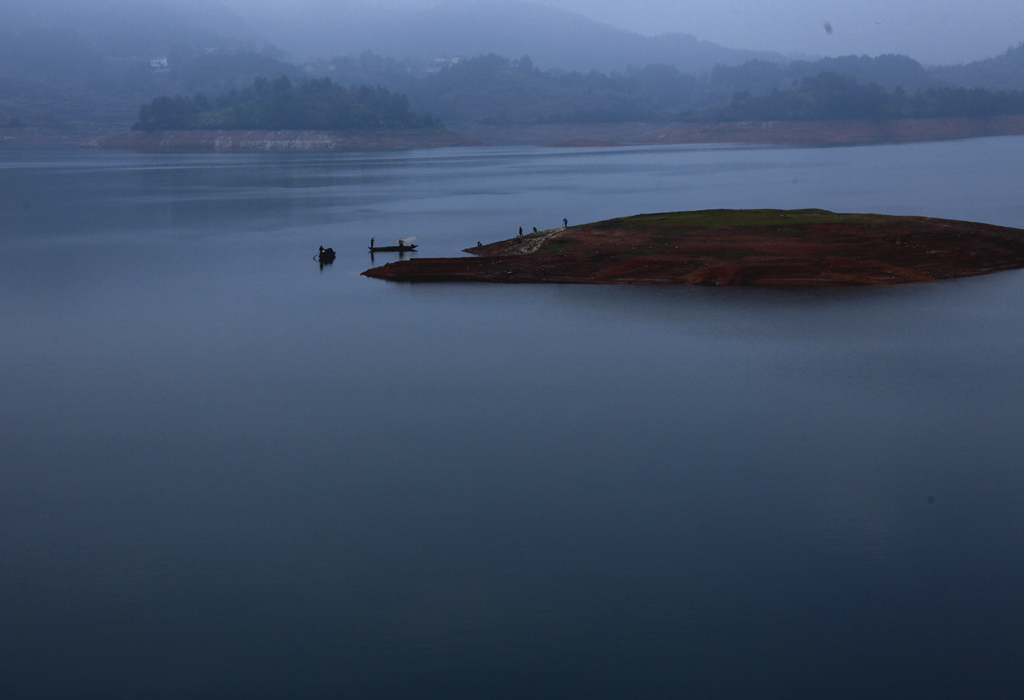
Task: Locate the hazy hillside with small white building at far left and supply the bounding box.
[0,0,288,129]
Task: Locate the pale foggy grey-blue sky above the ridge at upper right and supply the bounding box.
[222,0,1024,63]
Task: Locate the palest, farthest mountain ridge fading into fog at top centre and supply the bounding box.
[240,0,785,73]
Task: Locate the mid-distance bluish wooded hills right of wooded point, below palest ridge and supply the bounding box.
[312,52,942,126]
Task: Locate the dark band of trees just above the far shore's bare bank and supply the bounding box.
[133,54,1024,132]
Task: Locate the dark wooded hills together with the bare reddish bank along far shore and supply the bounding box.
[74,49,1024,150]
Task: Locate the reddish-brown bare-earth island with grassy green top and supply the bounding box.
[364,209,1024,287]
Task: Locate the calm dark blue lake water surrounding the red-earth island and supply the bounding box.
[0,137,1024,700]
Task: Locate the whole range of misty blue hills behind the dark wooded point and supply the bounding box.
[6,0,1024,138]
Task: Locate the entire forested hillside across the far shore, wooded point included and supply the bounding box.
[6,0,1024,139]
